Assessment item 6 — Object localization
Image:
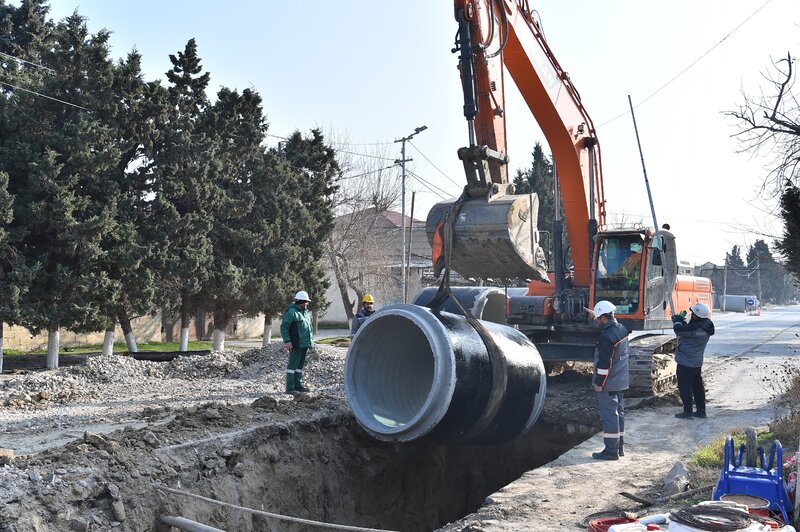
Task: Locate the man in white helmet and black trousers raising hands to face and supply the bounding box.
[672,303,714,419]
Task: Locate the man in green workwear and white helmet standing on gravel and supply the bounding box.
[281,290,314,393]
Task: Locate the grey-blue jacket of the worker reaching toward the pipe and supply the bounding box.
[592,318,630,392]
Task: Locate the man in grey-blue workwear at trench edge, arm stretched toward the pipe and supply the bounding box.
[585,300,630,460]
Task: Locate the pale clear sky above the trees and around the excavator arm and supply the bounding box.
[43,0,800,264]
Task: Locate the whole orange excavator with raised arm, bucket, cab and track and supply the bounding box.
[424,0,711,393]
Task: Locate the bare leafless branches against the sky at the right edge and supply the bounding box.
[726,53,800,195]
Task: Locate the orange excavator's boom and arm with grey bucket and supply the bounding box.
[427,0,605,286]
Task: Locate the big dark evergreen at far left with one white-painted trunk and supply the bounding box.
[0,13,125,367]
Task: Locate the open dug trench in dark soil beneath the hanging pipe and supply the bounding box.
[159,414,596,531]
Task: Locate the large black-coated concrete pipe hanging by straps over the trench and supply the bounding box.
[344,305,546,443]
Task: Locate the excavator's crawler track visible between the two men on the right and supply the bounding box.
[627,334,678,397]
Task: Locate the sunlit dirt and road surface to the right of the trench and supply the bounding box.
[443,306,800,532]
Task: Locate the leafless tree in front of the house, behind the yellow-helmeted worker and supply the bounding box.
[328,138,400,319]
